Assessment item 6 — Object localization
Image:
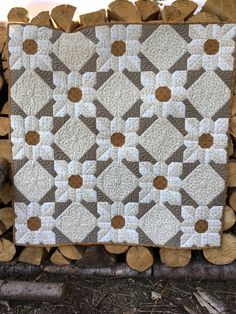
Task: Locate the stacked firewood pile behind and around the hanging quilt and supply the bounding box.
[0,0,236,272]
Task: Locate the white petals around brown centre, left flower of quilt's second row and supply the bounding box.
[53,71,96,117]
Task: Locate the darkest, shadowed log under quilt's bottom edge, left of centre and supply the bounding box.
[77,245,116,267]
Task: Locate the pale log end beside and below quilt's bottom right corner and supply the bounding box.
[203,233,236,265]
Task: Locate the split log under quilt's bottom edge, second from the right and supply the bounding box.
[160,248,192,267]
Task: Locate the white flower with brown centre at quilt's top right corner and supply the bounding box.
[188,24,236,71]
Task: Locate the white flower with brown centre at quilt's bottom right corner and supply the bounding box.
[181,206,223,248]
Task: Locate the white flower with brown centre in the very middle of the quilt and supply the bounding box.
[96,118,139,161]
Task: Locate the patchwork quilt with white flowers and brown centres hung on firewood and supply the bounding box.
[8,24,236,248]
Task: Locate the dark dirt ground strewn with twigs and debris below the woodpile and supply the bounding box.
[0,274,236,314]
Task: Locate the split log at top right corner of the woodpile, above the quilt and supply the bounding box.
[202,0,236,22]
